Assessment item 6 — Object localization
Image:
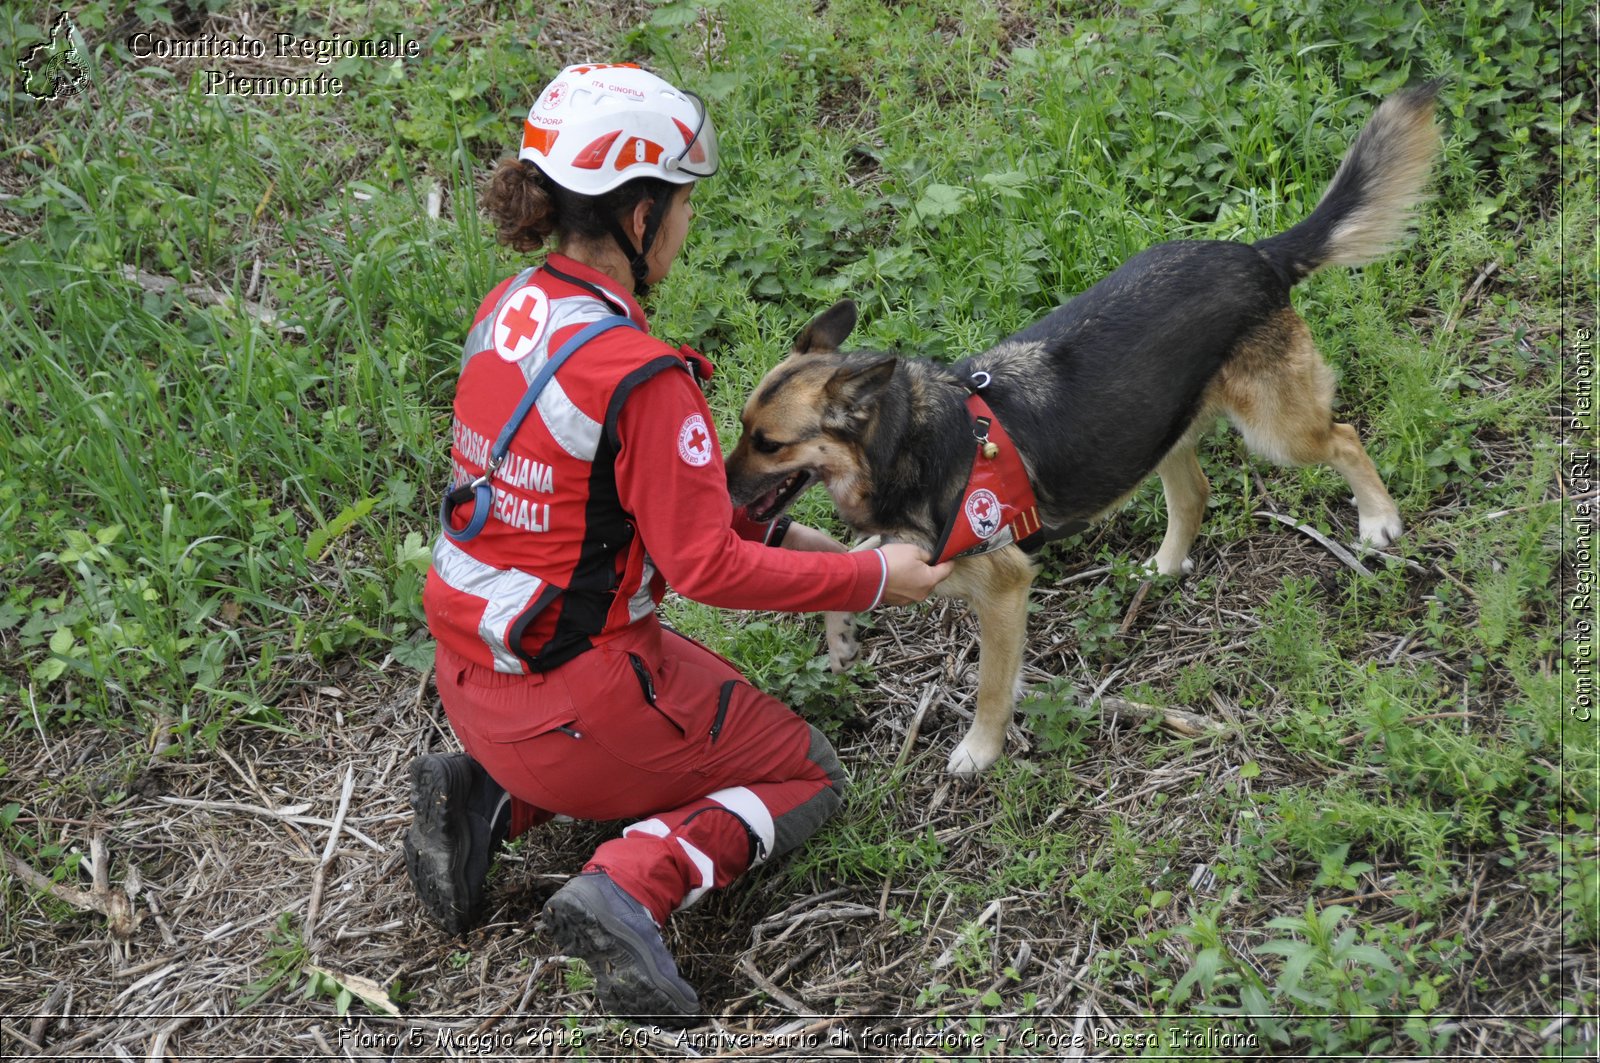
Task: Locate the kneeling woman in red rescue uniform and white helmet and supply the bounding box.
[405,66,949,1023]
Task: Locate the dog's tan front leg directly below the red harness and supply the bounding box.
[939,546,1034,775]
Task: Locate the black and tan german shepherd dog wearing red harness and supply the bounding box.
[728,83,1438,773]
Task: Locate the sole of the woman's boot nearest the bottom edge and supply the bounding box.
[544,877,701,1028]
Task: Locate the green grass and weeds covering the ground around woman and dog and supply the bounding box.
[0,0,1600,1052]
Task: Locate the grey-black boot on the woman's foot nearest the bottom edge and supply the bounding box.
[544,871,701,1028]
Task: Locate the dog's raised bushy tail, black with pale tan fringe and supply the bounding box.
[1254,82,1440,283]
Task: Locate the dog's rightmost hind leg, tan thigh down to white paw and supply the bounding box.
[1213,311,1403,549]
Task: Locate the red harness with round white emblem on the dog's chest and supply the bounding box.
[933,392,1040,565]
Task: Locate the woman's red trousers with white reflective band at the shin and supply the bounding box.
[437,616,845,924]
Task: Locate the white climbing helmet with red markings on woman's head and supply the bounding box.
[517,62,717,195]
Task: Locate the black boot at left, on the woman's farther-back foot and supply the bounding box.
[405,752,510,935]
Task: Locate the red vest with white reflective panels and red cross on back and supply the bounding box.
[422,266,688,674]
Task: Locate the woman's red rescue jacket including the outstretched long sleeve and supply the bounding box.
[422,255,885,672]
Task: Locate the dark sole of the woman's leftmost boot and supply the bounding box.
[405,754,474,933]
